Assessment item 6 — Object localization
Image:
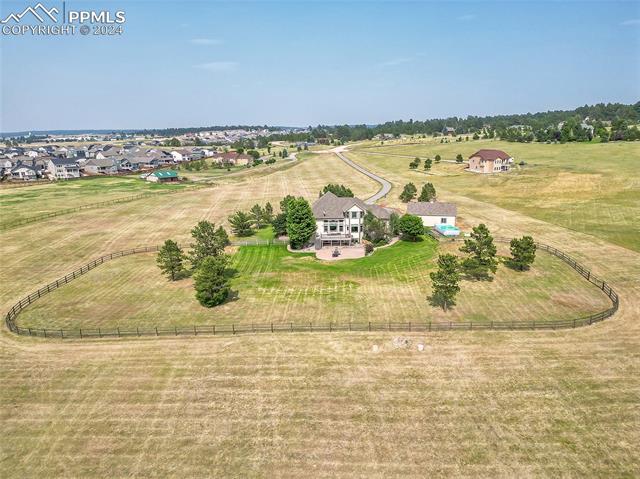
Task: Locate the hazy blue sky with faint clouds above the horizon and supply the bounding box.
[0,0,640,131]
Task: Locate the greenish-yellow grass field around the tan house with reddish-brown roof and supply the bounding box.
[347,140,640,251]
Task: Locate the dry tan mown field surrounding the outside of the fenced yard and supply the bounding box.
[0,145,640,478]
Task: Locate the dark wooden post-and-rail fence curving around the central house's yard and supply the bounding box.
[5,238,619,339]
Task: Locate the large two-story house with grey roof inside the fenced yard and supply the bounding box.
[311,192,393,248]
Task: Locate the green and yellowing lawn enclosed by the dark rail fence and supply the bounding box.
[19,240,609,329]
